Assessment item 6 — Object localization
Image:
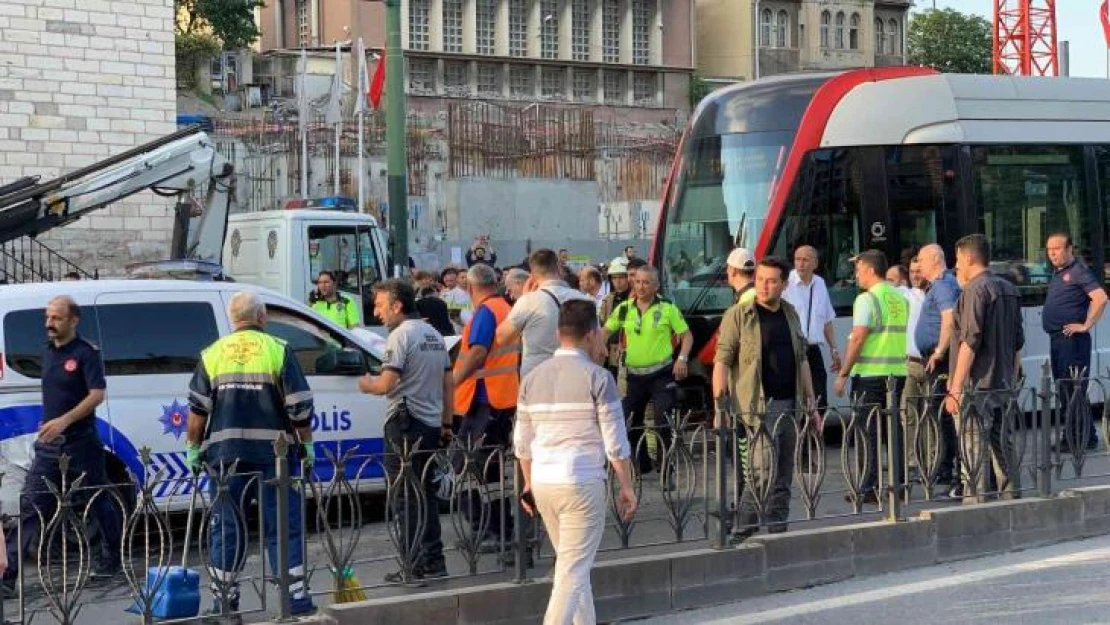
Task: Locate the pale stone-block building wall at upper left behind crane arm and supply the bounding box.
[0,0,176,275]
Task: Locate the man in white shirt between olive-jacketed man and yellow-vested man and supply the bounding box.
[783,245,840,409]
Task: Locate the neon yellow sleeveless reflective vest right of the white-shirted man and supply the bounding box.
[852,282,909,377]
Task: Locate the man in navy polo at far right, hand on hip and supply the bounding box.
[1041,232,1107,452]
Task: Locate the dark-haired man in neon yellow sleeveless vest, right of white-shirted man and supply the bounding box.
[834,250,909,504]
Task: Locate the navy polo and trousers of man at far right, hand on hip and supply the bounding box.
[1041,259,1102,446]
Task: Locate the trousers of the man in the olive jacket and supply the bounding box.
[740,400,800,532]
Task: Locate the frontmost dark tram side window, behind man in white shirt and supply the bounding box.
[774,149,864,315]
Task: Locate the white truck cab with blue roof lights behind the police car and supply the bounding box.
[223,198,390,325]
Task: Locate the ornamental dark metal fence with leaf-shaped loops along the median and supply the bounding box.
[0,366,1110,624]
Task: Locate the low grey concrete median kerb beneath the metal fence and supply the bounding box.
[259,486,1110,625]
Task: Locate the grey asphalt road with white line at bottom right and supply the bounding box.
[636,536,1110,625]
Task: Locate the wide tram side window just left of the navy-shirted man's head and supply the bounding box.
[971,145,1093,306]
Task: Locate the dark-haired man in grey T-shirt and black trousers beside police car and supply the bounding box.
[359,278,452,583]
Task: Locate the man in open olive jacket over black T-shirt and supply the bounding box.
[713,259,816,534]
